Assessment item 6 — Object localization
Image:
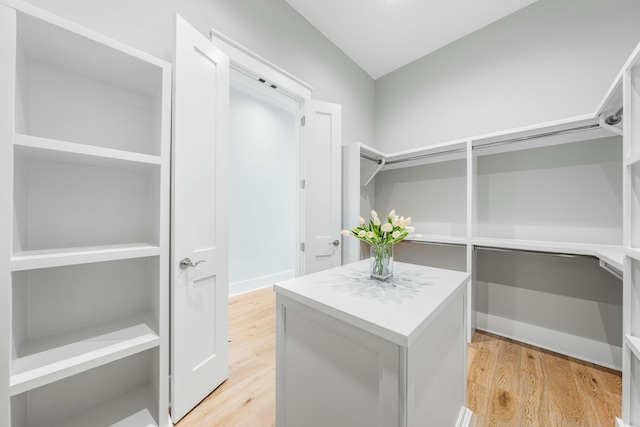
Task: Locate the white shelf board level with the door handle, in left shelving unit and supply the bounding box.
[11,243,160,271]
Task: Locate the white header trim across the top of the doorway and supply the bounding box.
[209,28,313,99]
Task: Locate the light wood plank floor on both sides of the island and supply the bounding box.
[177,288,622,427]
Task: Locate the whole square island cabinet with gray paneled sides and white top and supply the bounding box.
[274,260,471,427]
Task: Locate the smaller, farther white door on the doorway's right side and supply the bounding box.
[302,100,342,274]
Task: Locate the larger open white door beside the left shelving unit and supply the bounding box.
[171,16,229,423]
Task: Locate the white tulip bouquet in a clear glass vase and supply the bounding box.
[342,210,416,280]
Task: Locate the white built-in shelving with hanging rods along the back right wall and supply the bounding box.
[343,56,628,369]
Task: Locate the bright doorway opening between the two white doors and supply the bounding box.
[229,68,302,295]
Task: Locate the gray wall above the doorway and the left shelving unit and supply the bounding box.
[23,0,375,144]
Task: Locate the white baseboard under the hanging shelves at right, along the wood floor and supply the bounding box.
[476,312,622,371]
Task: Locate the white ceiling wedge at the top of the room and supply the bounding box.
[285,0,537,79]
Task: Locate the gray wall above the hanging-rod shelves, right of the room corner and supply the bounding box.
[376,0,640,152]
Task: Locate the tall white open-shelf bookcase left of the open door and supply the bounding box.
[0,0,171,427]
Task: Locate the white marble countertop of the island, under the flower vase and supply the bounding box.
[274,260,470,347]
